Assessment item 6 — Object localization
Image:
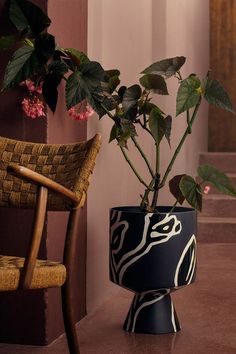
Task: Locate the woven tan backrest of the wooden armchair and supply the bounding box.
[0,135,100,210]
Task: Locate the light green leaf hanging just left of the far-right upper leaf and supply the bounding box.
[176,74,201,116]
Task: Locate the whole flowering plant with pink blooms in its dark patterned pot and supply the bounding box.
[0,0,236,333]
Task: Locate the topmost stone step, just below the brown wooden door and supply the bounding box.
[199,152,236,173]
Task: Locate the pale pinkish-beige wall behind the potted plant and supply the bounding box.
[87,0,209,312]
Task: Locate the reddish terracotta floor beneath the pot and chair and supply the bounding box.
[0,243,236,354]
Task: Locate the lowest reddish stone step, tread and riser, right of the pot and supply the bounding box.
[197,216,236,243]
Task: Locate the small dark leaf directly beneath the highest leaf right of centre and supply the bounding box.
[139,74,168,95]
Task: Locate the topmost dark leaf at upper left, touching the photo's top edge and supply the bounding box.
[9,0,51,36]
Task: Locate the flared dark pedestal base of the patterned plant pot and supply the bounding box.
[123,290,181,334]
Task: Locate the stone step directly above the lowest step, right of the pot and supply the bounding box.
[201,194,236,218]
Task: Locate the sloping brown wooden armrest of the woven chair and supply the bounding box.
[8,165,80,206]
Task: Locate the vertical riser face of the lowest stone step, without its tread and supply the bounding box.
[197,222,236,243]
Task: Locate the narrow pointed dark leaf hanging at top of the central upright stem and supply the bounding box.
[148,108,166,145]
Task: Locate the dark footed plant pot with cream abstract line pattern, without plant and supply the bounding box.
[110,207,197,334]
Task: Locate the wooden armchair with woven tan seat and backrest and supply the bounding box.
[0,134,100,354]
